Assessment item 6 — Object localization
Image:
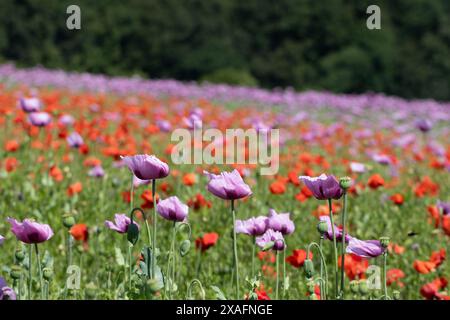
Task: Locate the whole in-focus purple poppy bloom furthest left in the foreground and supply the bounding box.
[6,218,53,244]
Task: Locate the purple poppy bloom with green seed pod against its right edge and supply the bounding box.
[299,173,342,200]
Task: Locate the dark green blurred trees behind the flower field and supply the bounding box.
[0,0,450,100]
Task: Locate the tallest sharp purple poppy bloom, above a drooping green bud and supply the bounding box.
[121,154,169,180]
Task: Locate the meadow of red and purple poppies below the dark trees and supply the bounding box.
[0,65,450,300]
